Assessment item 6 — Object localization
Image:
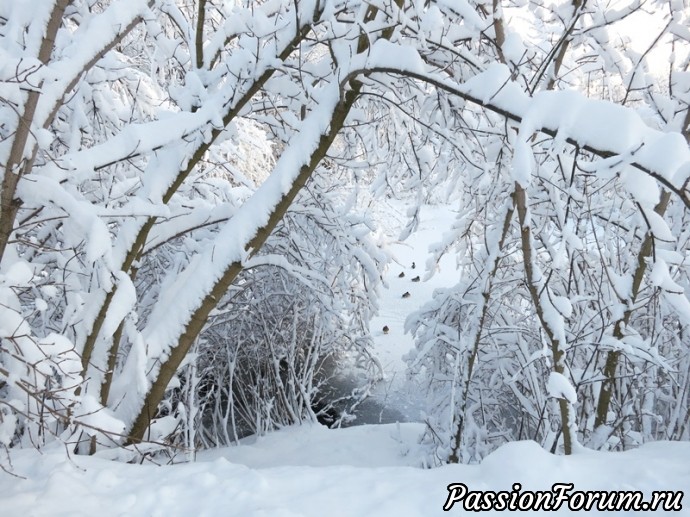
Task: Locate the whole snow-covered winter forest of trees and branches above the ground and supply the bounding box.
[0,0,690,515]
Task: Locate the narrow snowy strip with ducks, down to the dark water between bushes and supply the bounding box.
[320,199,459,425]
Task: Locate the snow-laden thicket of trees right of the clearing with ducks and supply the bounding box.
[408,2,690,463]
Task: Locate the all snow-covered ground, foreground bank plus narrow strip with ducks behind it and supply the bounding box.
[0,202,690,517]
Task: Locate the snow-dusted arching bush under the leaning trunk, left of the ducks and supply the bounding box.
[164,173,385,447]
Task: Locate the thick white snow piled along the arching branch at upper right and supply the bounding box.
[374,58,690,198]
